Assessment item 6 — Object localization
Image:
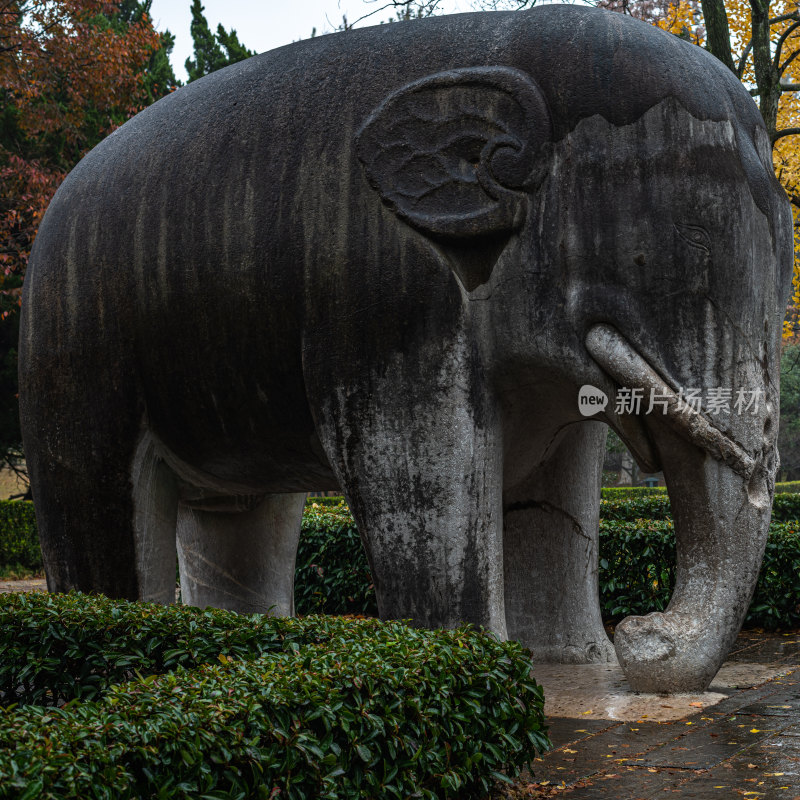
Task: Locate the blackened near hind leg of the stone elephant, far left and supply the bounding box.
[26,408,177,603]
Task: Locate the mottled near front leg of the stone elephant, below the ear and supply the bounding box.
[319,354,506,639]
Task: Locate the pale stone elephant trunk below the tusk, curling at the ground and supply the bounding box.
[614,422,772,692]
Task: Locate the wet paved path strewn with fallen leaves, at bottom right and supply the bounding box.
[508,631,800,800]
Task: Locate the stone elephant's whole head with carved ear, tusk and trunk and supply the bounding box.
[357,17,792,692]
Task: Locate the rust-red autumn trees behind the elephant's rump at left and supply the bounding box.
[0,0,170,482]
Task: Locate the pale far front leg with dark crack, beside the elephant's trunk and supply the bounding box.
[504,422,616,664]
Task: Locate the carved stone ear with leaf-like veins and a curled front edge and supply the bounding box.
[356,67,552,239]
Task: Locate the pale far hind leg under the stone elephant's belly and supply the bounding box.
[178,493,306,616]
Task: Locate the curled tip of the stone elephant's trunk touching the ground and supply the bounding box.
[614,612,718,694]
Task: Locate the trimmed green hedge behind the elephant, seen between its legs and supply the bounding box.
[0,492,800,627]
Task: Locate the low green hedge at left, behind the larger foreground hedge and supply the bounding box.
[0,593,351,705]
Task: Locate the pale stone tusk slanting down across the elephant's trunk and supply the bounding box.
[586,324,756,480]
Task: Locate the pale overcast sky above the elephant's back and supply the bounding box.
[150,0,474,81]
